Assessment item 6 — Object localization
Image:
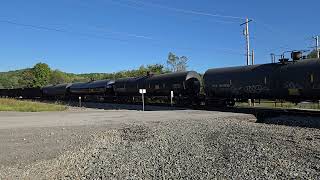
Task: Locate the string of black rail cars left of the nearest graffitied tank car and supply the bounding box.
[0,71,201,104]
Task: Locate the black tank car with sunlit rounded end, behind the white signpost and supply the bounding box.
[114,71,201,104]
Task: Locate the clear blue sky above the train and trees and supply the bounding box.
[0,0,320,73]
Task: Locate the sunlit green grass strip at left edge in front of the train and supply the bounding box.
[0,98,67,112]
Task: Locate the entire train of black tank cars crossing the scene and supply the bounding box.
[0,52,320,106]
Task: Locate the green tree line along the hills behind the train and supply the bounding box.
[0,52,188,88]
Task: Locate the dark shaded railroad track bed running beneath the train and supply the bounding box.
[20,97,320,129]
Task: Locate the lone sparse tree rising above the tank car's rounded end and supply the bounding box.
[167,52,188,72]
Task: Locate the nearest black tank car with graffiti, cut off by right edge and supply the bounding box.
[204,59,320,105]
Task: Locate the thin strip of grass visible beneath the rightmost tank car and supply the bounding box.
[236,100,320,110]
